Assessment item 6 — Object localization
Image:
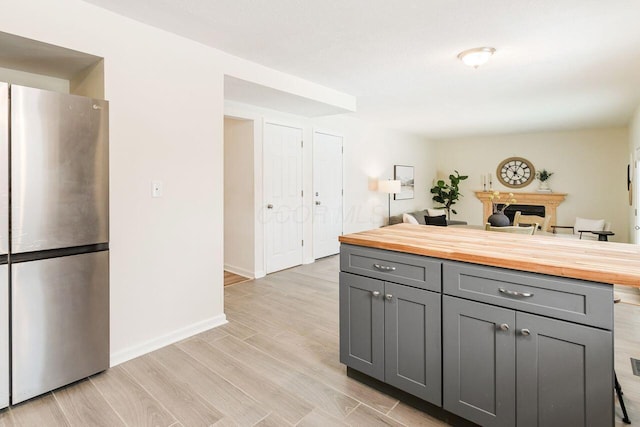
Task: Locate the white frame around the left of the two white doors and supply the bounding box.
[264,117,306,277]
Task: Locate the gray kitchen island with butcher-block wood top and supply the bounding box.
[340,224,640,426]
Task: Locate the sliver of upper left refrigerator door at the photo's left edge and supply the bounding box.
[0,82,9,254]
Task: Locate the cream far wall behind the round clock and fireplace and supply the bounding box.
[436,128,629,242]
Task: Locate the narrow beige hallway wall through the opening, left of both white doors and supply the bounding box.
[224,117,255,277]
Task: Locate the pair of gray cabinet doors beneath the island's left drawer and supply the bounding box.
[340,272,442,405]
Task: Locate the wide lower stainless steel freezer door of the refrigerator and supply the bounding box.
[11,251,109,404]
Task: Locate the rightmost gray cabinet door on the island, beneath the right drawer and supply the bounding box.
[516,313,614,427]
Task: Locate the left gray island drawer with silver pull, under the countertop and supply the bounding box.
[340,245,442,292]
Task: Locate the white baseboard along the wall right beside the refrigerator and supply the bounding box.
[109,313,228,367]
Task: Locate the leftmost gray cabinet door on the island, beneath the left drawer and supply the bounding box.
[340,273,384,381]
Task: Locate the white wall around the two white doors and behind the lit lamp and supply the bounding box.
[225,102,435,277]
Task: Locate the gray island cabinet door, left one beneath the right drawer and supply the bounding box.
[442,295,516,426]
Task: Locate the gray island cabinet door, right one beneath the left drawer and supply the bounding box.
[384,283,442,406]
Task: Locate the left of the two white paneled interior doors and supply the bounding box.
[264,123,302,273]
